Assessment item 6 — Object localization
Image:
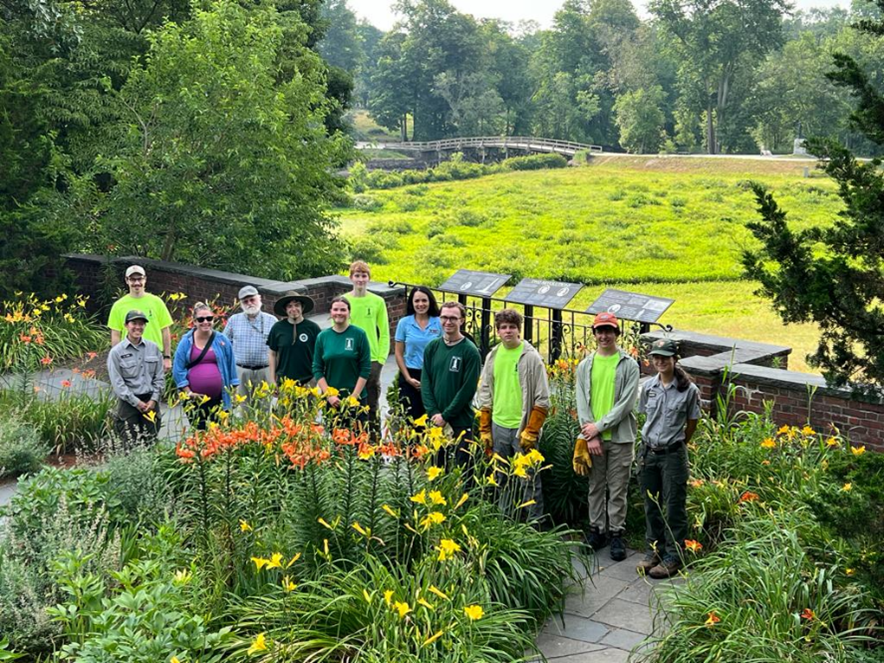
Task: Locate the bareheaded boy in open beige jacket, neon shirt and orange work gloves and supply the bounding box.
[479,309,549,522]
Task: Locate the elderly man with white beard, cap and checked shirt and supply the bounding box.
[224,285,276,399]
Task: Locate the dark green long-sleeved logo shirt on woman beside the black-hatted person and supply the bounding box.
[313,325,371,398]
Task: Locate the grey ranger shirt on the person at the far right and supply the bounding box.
[638,374,700,449]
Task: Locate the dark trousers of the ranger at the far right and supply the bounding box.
[641,444,688,559]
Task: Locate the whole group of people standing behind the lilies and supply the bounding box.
[108,261,700,578]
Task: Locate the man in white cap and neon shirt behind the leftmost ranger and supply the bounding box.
[107,265,172,371]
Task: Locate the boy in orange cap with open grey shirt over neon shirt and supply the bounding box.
[574,312,639,562]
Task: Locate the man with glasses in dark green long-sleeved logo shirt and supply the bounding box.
[421,302,482,466]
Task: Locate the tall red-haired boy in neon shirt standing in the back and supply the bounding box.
[344,260,390,436]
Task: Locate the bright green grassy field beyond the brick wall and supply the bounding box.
[340,157,840,370]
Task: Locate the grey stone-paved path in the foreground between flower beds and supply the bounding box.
[537,548,679,663]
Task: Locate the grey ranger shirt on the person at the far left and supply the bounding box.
[107,336,166,407]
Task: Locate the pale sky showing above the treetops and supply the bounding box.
[347,0,850,30]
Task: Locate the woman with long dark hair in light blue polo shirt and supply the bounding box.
[396,286,442,419]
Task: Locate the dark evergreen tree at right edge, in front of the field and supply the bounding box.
[744,0,884,393]
